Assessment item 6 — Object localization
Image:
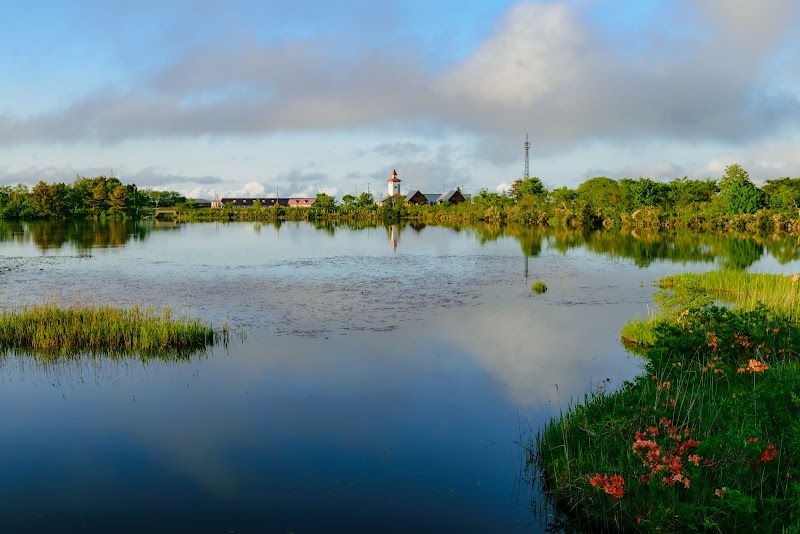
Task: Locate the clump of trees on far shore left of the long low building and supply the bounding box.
[0,176,190,220]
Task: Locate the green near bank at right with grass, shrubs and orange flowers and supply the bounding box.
[531,271,800,532]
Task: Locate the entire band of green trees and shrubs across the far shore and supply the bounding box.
[0,164,800,234]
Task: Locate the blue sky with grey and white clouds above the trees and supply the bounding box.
[0,0,800,199]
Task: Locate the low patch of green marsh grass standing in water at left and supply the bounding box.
[0,304,229,357]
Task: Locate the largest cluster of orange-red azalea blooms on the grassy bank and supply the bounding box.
[631,417,711,488]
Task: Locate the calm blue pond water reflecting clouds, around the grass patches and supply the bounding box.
[0,223,798,533]
